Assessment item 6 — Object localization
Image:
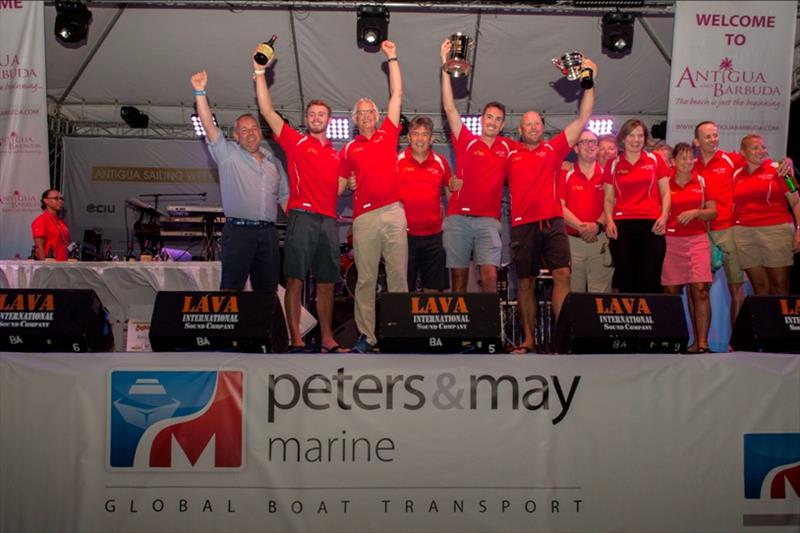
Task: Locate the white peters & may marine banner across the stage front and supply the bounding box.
[0,353,800,533]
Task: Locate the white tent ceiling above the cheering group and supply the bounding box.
[45,0,800,134]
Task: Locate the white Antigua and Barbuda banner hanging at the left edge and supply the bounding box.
[0,0,50,259]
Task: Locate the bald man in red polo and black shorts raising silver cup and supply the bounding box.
[507,58,597,353]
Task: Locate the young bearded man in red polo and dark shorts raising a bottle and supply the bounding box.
[253,55,347,353]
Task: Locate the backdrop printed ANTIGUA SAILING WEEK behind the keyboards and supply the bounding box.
[63,137,221,254]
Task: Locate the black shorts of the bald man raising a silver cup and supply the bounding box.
[511,217,572,278]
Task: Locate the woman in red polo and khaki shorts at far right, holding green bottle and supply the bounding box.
[733,134,800,294]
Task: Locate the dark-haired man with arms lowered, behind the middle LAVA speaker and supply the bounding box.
[397,116,450,292]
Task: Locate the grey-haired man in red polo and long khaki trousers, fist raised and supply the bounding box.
[339,41,408,353]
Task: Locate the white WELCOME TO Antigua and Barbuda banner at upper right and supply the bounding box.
[667,1,797,154]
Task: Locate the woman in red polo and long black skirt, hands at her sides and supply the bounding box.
[603,119,670,293]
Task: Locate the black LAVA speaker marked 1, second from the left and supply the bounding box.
[150,291,288,353]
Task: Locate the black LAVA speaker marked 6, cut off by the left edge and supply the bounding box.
[0,289,114,352]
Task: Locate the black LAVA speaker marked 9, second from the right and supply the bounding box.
[555,292,689,354]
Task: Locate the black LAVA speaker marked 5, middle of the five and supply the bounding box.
[377,292,502,353]
